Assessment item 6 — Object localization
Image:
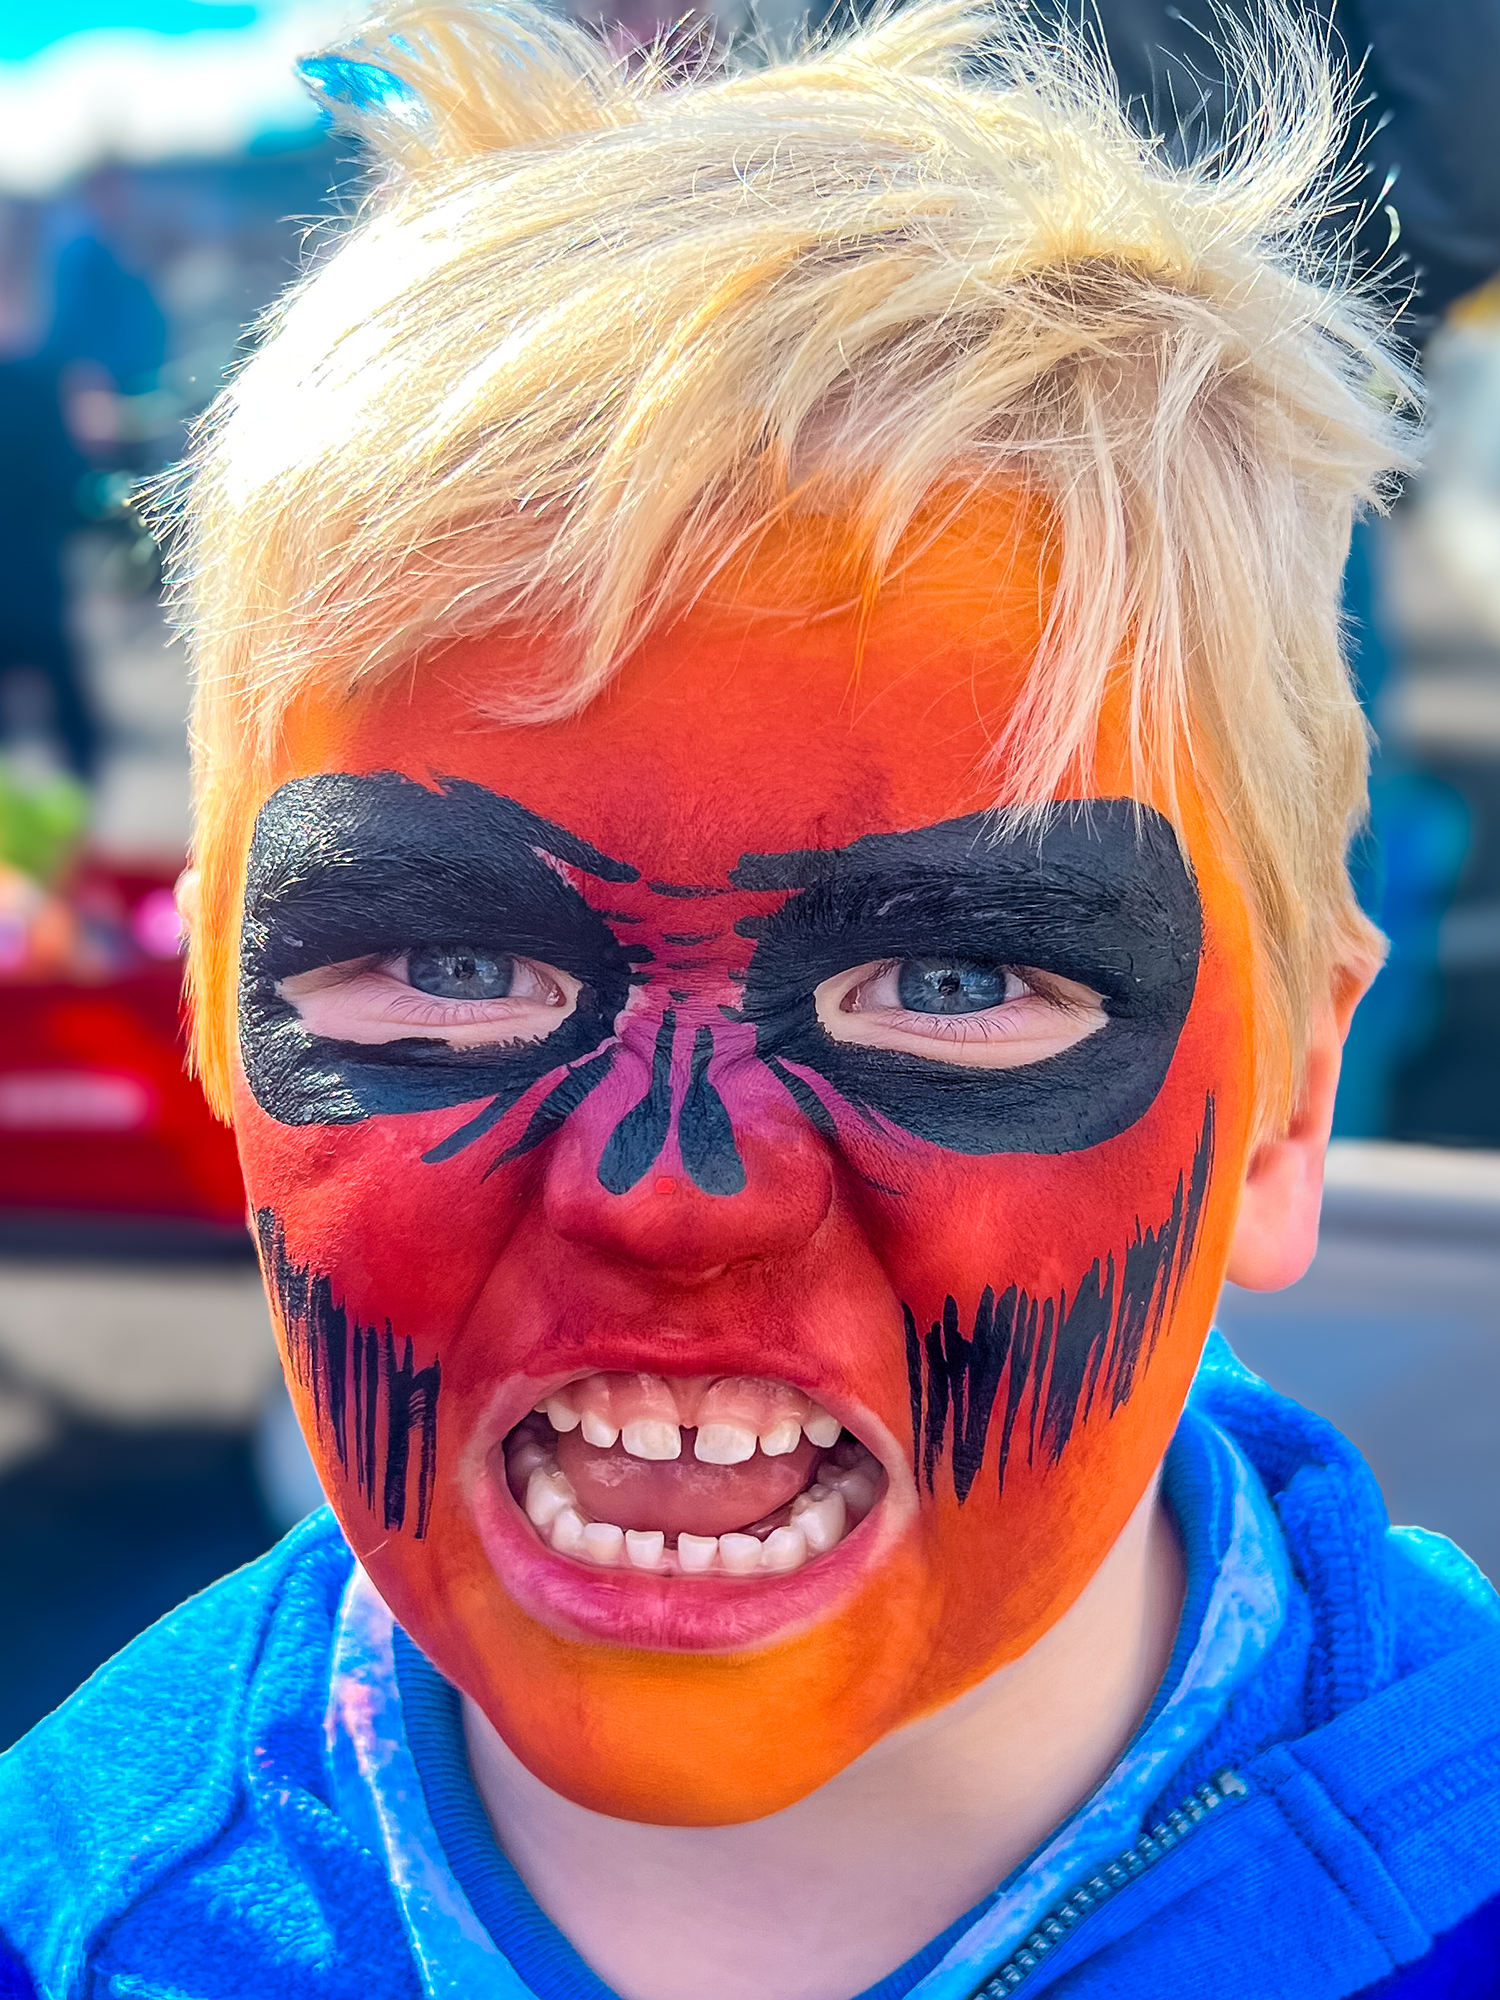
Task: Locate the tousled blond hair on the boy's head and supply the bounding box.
[176,0,1410,1118]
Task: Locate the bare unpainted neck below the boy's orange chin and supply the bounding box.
[464,1488,1182,2000]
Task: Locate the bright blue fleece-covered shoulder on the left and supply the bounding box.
[0,1508,410,2000]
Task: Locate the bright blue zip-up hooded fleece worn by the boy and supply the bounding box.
[0,1342,1500,2000]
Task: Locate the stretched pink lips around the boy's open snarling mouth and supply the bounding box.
[464,1360,916,1652]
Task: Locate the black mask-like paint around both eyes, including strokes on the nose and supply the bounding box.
[240,772,1202,1168]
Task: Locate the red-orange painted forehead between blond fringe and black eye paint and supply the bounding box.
[284,494,1118,880]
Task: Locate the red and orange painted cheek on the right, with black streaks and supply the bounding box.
[848,936,1252,1700]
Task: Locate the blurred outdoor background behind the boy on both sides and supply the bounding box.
[0,0,1500,1744]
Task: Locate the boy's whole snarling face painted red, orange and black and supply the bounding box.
[236,504,1250,1824]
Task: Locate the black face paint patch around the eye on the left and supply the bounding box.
[240,772,650,1156]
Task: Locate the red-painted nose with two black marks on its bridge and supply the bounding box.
[544,1010,834,1276]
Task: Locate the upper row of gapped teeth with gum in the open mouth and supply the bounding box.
[536,1374,842,1466]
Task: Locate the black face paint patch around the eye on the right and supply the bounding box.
[732,800,1202,1154]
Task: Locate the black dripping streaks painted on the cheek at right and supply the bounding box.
[902,1096,1214,1504]
